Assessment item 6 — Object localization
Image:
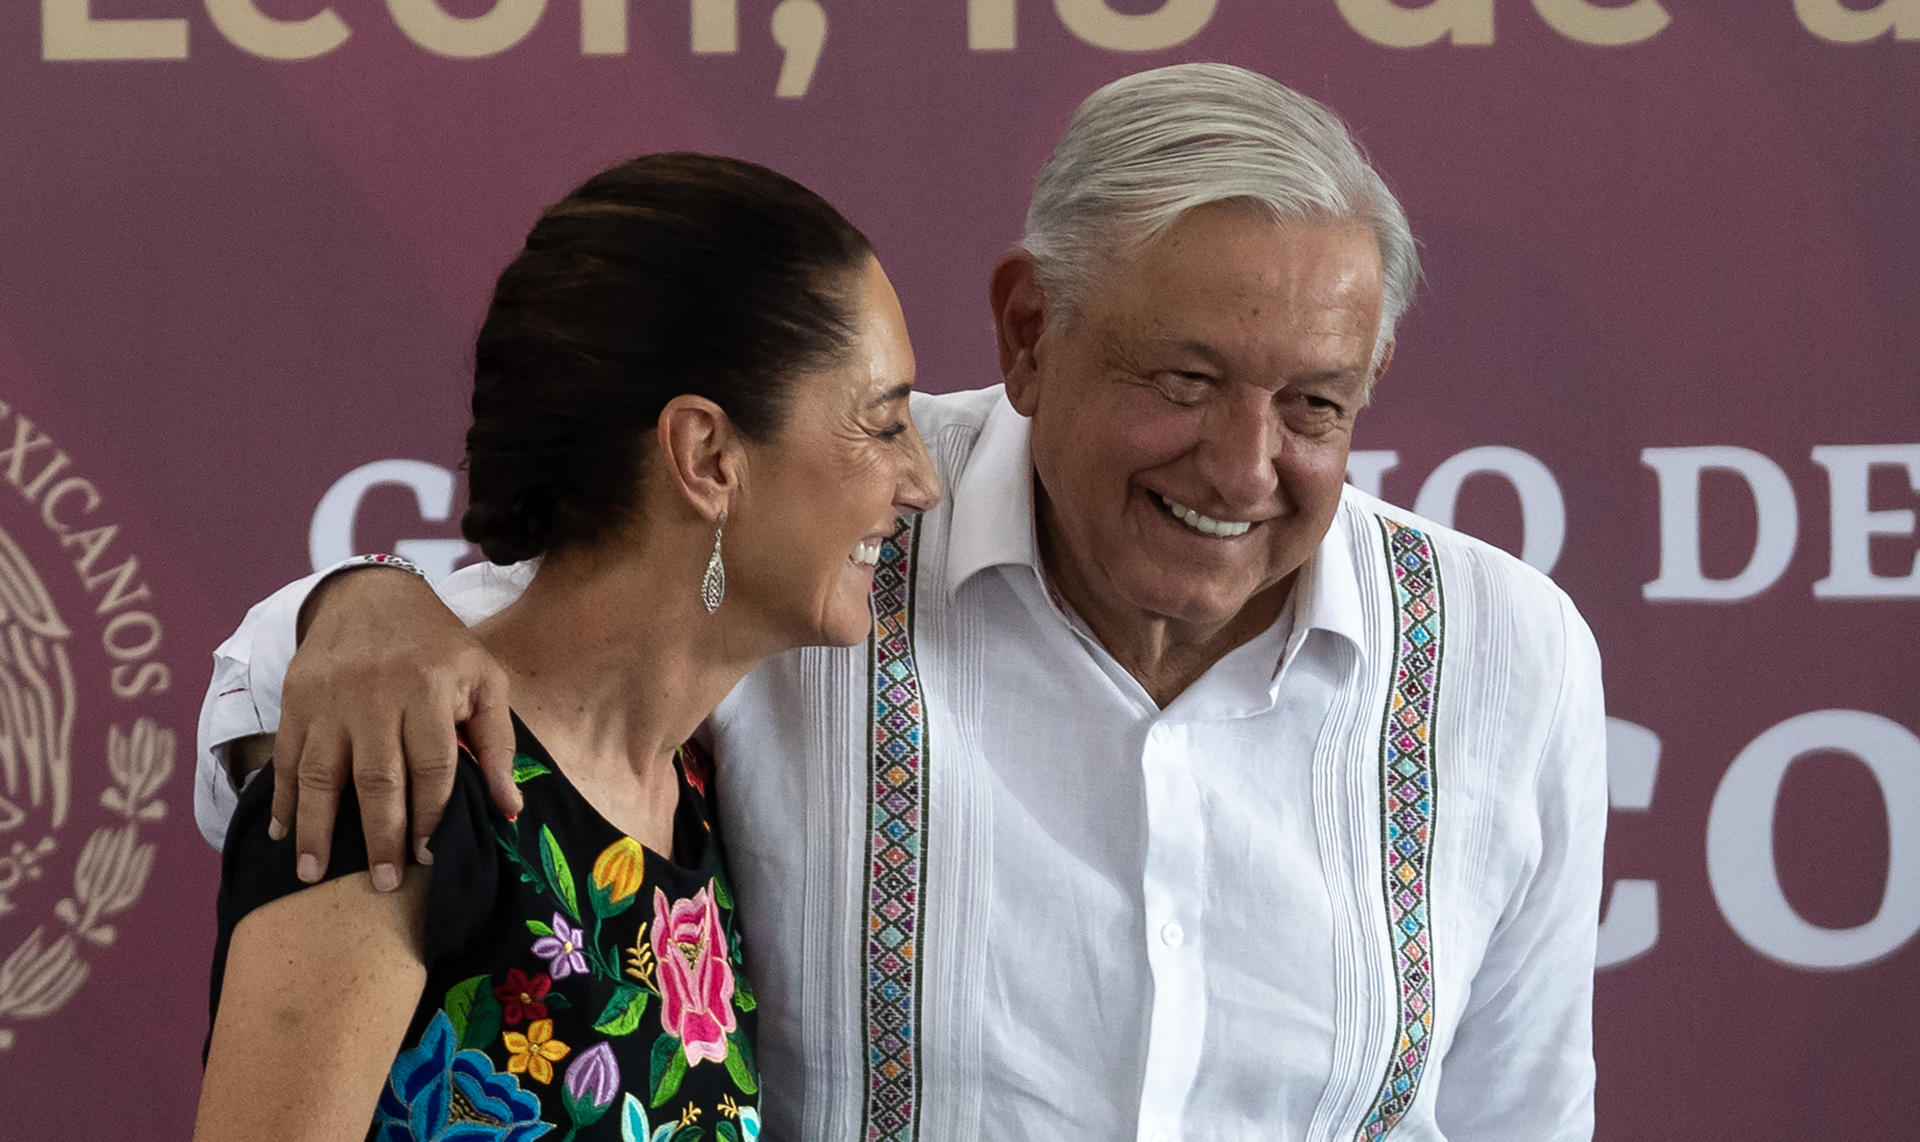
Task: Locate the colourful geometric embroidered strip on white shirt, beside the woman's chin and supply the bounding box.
[864,520,927,1142]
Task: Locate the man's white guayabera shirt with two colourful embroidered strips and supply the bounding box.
[196,388,1607,1142]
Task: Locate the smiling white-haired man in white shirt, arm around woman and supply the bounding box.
[198,63,1607,1142]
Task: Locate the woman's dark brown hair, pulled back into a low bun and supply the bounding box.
[461,154,874,562]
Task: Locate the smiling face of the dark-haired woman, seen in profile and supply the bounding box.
[726,261,941,647]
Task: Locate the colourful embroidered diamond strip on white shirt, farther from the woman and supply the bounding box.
[1356,520,1444,1142]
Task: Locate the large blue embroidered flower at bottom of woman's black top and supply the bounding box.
[372,1011,553,1142]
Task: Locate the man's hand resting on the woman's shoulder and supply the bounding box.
[271,568,520,891]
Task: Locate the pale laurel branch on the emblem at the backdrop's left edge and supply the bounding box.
[0,718,175,1050]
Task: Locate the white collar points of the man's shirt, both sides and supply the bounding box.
[947,389,1367,656]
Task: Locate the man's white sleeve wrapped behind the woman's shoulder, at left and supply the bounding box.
[194,557,536,848]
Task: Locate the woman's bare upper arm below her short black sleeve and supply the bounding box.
[194,868,432,1142]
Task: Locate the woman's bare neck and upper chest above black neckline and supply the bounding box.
[474,547,768,852]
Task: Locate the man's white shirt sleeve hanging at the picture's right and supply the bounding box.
[1436,597,1607,1142]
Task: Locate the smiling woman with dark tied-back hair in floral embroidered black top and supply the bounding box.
[196,154,939,1142]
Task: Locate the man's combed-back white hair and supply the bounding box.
[1021,63,1421,365]
